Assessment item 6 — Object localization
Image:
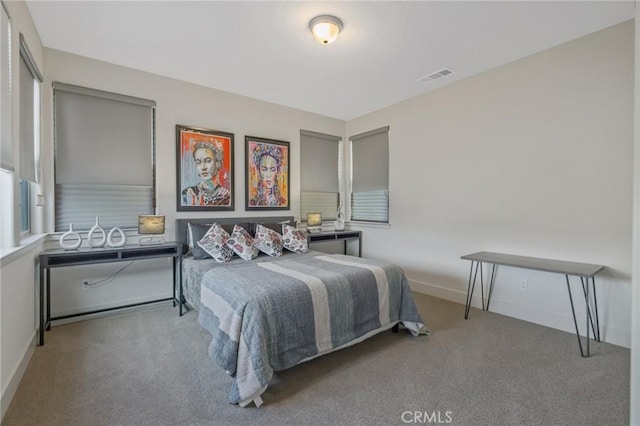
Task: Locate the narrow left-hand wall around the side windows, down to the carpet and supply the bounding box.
[0,1,44,418]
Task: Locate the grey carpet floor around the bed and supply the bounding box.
[2,294,630,426]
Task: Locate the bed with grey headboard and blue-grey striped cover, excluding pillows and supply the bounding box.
[176,216,428,407]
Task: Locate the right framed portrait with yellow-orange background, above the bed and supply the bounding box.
[244,136,289,210]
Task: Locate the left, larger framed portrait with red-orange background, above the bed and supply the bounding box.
[176,125,234,211]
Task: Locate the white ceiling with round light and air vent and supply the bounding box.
[27,0,635,120]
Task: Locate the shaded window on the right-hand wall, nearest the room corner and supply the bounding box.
[350,127,389,223]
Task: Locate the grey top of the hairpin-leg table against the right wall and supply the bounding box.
[461,251,604,277]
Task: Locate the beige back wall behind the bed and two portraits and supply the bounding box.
[43,49,345,315]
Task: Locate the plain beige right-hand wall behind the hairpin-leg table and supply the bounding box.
[347,21,634,347]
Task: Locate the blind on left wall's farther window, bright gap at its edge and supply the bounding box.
[20,34,42,182]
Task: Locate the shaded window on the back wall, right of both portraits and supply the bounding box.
[300,130,342,222]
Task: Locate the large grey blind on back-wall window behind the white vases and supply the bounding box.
[53,82,155,231]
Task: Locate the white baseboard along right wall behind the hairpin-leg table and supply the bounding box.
[409,280,631,348]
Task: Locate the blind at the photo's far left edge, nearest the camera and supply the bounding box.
[0,3,14,172]
